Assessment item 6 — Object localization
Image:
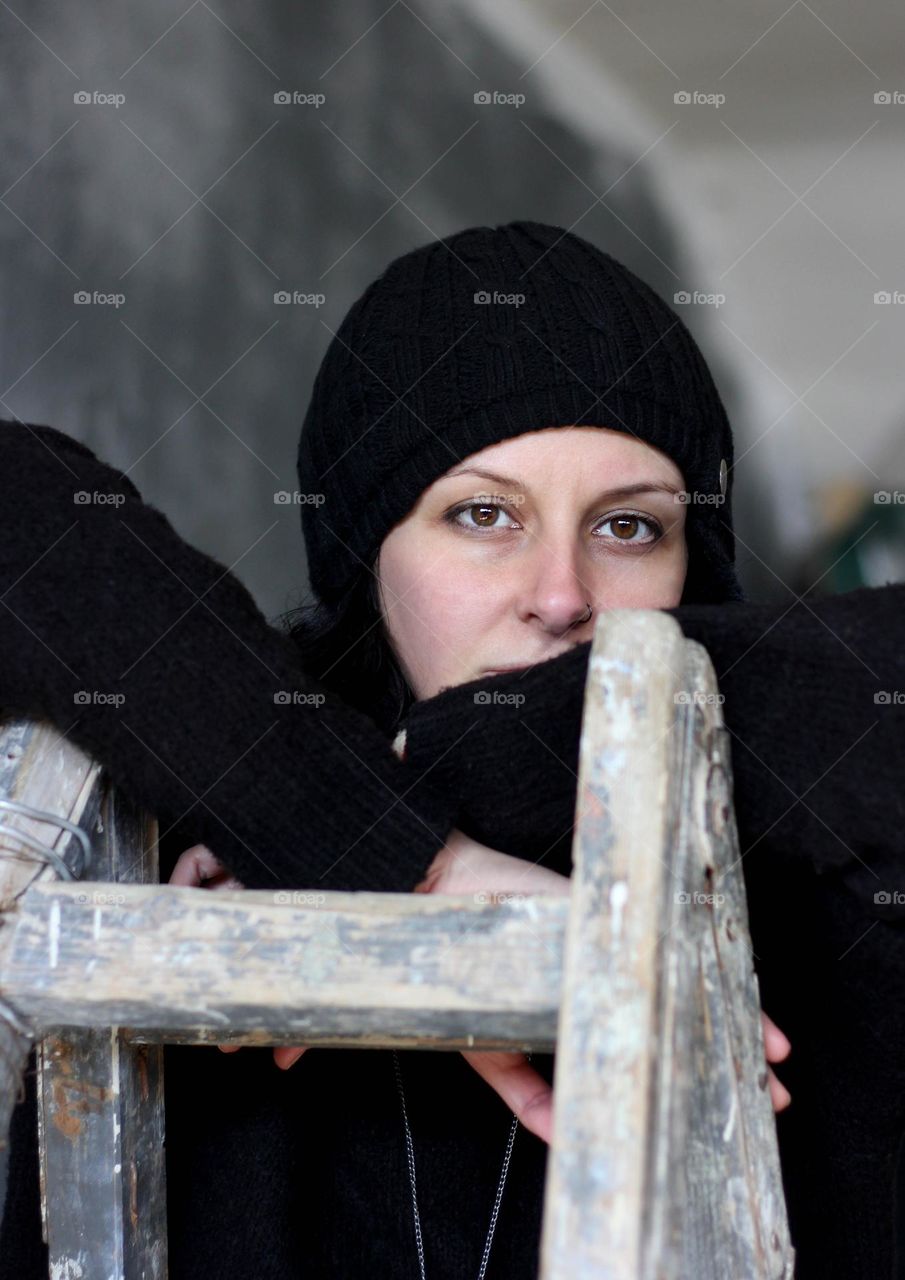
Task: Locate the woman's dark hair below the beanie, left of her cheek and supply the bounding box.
[278,566,416,735]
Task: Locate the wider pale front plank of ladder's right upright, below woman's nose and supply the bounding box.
[541,613,684,1280]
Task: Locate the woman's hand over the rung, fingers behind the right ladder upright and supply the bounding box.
[413,831,791,1143]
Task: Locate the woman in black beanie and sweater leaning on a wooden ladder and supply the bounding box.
[0,223,905,1276]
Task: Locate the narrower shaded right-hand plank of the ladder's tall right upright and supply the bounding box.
[677,645,794,1280]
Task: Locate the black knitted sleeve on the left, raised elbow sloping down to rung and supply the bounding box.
[0,422,454,892]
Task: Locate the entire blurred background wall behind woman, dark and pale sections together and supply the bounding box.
[0,0,905,617]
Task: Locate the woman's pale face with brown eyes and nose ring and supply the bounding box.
[376,426,687,700]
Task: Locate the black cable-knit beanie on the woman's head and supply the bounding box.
[298,221,744,604]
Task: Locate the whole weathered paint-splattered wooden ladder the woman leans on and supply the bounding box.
[0,609,794,1280]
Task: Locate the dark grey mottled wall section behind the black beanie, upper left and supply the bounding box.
[0,0,769,616]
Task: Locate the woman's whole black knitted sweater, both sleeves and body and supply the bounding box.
[0,422,905,1280]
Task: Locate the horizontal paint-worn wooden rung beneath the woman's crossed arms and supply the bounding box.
[0,883,568,1052]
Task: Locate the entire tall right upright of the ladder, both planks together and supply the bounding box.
[541,611,794,1280]
